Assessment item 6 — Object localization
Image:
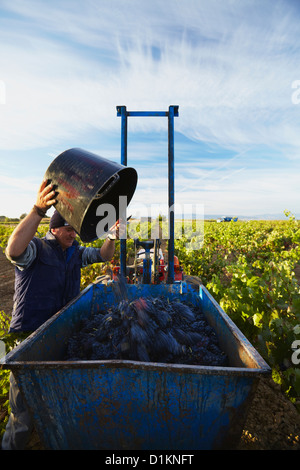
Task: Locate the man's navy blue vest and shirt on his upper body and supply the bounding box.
[9,232,103,332]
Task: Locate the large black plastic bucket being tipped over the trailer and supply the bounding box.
[45,148,137,242]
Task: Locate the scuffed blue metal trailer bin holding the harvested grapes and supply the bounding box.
[2,284,270,450]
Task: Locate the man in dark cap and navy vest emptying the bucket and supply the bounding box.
[2,180,119,450]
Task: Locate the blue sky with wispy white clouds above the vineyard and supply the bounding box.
[0,0,300,217]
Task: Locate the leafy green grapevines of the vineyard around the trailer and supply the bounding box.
[0,213,300,443]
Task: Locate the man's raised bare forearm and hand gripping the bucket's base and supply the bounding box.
[6,180,56,259]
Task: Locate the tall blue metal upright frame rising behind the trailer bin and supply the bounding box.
[117,105,179,284]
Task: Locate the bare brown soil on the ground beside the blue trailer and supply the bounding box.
[0,250,300,450]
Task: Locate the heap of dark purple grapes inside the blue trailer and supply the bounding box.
[66,297,227,366]
